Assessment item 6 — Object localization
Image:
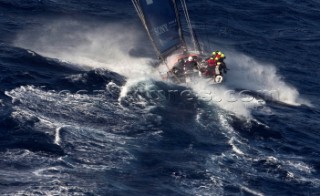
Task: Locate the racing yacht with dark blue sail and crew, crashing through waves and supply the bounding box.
[132,0,223,84]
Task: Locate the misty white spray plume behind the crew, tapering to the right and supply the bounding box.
[225,52,311,106]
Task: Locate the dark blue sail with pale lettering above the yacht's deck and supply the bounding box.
[132,0,185,59]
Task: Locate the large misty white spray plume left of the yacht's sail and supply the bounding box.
[14,20,158,78]
